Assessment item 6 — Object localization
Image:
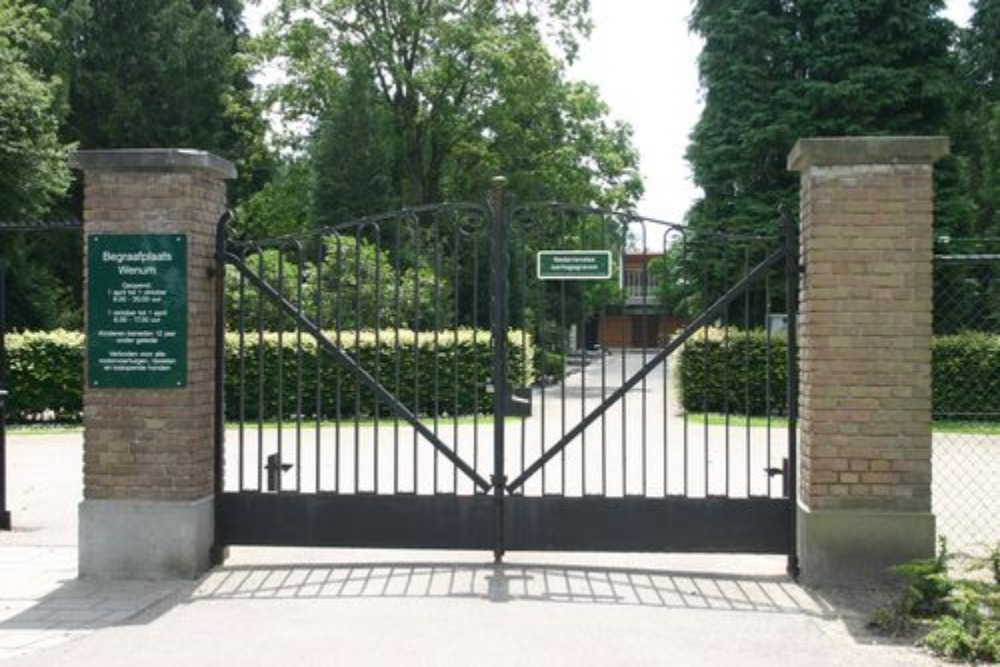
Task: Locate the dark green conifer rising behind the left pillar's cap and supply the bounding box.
[64,0,267,198]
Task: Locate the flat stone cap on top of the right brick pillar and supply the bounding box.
[788,137,950,171]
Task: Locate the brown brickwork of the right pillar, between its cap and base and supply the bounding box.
[800,158,933,511]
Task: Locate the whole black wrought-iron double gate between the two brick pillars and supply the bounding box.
[217,183,797,558]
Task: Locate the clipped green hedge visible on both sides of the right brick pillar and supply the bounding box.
[680,330,1000,420]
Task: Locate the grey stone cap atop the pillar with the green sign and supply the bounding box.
[69,148,236,180]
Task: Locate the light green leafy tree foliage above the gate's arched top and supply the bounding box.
[250,0,641,224]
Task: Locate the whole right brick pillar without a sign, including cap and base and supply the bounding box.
[788,137,948,585]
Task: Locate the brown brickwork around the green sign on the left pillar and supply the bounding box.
[83,169,225,500]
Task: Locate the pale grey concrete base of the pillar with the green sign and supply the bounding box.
[79,496,215,580]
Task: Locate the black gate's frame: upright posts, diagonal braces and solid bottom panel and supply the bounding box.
[216,187,799,571]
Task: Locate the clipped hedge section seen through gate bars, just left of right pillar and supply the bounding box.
[679,329,787,415]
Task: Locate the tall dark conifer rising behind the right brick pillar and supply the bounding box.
[688,0,953,244]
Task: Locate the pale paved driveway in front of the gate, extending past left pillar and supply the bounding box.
[0,426,933,667]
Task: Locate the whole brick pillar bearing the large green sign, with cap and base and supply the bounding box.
[70,149,236,579]
